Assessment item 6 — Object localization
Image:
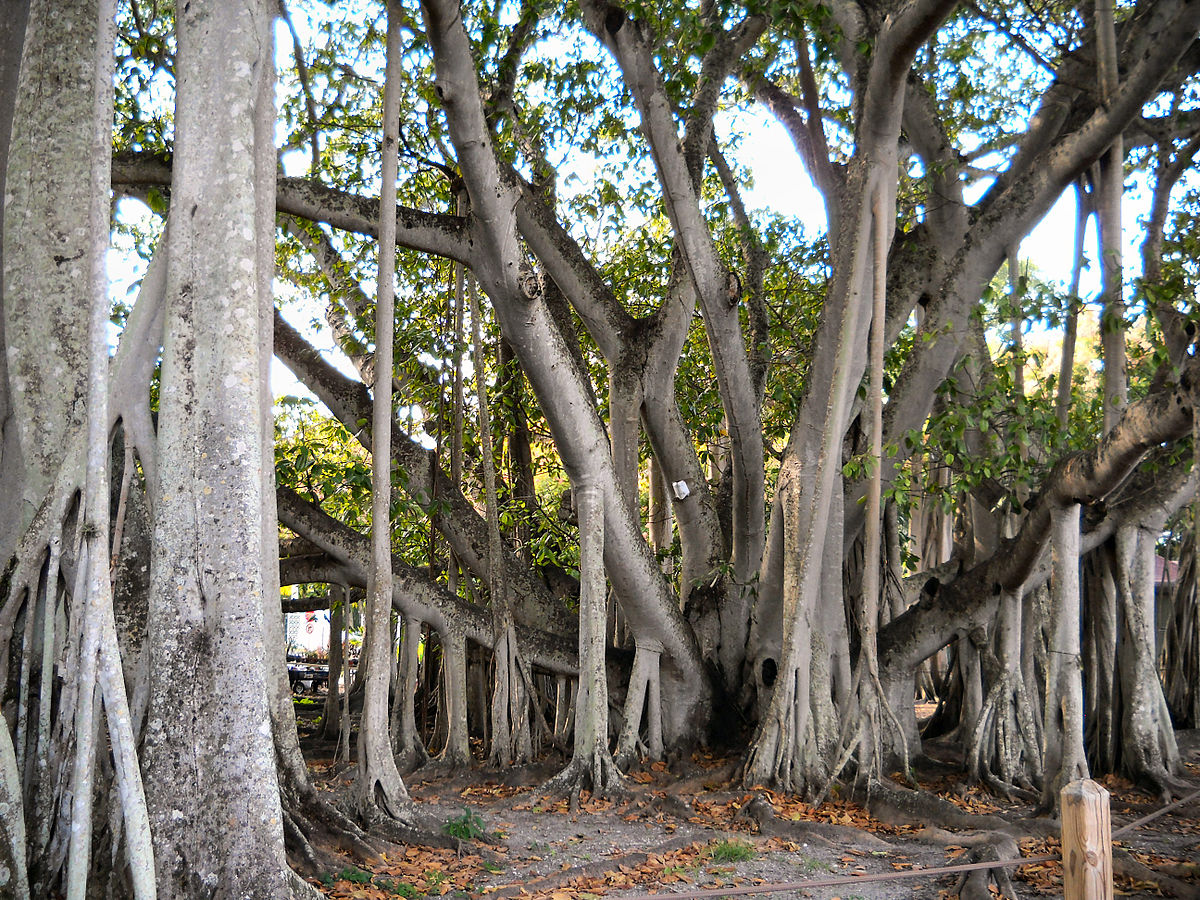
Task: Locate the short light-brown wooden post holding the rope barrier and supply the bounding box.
[1062,779,1112,900]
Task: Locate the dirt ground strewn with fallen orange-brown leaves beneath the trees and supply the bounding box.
[292,705,1200,900]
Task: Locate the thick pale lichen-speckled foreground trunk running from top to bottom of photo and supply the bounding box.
[143,2,292,900]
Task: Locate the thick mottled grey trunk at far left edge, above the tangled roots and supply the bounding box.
[2,2,97,534]
